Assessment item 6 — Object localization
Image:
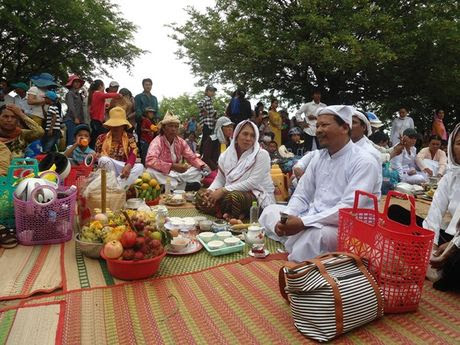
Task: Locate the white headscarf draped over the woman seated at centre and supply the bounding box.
[219,120,260,184]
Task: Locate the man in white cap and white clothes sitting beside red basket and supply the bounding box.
[259,105,381,262]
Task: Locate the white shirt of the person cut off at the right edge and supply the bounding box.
[423,170,460,244]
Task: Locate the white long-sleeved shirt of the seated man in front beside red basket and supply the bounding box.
[286,140,382,228]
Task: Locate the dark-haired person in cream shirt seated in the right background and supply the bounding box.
[416,135,447,177]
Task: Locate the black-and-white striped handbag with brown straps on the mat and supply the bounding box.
[279,253,383,341]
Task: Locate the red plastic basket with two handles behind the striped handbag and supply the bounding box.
[338,191,434,313]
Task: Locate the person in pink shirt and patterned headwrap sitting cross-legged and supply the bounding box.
[145,111,209,191]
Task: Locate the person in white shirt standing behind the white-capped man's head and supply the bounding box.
[295,89,326,151]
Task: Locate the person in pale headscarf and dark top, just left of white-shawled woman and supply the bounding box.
[202,116,234,187]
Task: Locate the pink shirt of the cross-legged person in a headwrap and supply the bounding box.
[145,135,205,174]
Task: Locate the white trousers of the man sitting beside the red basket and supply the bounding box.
[259,205,337,262]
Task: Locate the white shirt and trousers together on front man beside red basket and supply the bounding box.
[259,140,381,261]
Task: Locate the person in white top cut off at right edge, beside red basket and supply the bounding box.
[388,124,460,290]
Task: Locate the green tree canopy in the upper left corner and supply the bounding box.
[0,0,143,80]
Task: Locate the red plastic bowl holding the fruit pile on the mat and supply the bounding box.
[101,250,166,280]
